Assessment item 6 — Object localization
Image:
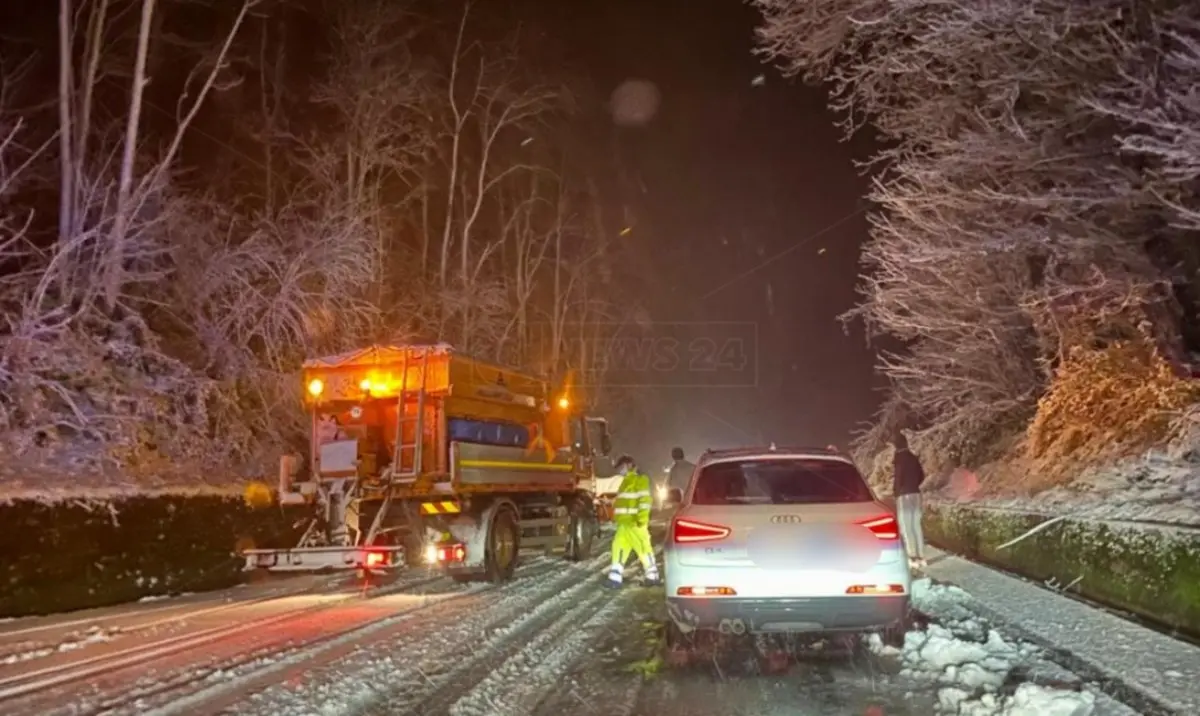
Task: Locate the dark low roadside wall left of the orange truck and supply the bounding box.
[0,495,306,618]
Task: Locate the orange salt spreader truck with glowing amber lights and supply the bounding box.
[244,344,612,582]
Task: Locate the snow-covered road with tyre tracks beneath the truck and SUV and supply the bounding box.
[0,539,1183,716]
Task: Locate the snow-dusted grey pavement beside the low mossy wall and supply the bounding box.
[921,550,1200,716]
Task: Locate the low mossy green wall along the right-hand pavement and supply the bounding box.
[924,501,1200,638]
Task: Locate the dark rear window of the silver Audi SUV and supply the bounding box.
[691,458,875,505]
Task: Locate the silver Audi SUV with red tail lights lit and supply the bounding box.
[664,445,912,643]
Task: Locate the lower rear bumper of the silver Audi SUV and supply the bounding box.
[667,595,910,632]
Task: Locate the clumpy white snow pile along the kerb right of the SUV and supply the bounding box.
[869,579,1096,716]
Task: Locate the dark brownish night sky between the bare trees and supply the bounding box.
[552,0,878,462]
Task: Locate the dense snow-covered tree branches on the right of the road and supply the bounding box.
[755,0,1200,462]
